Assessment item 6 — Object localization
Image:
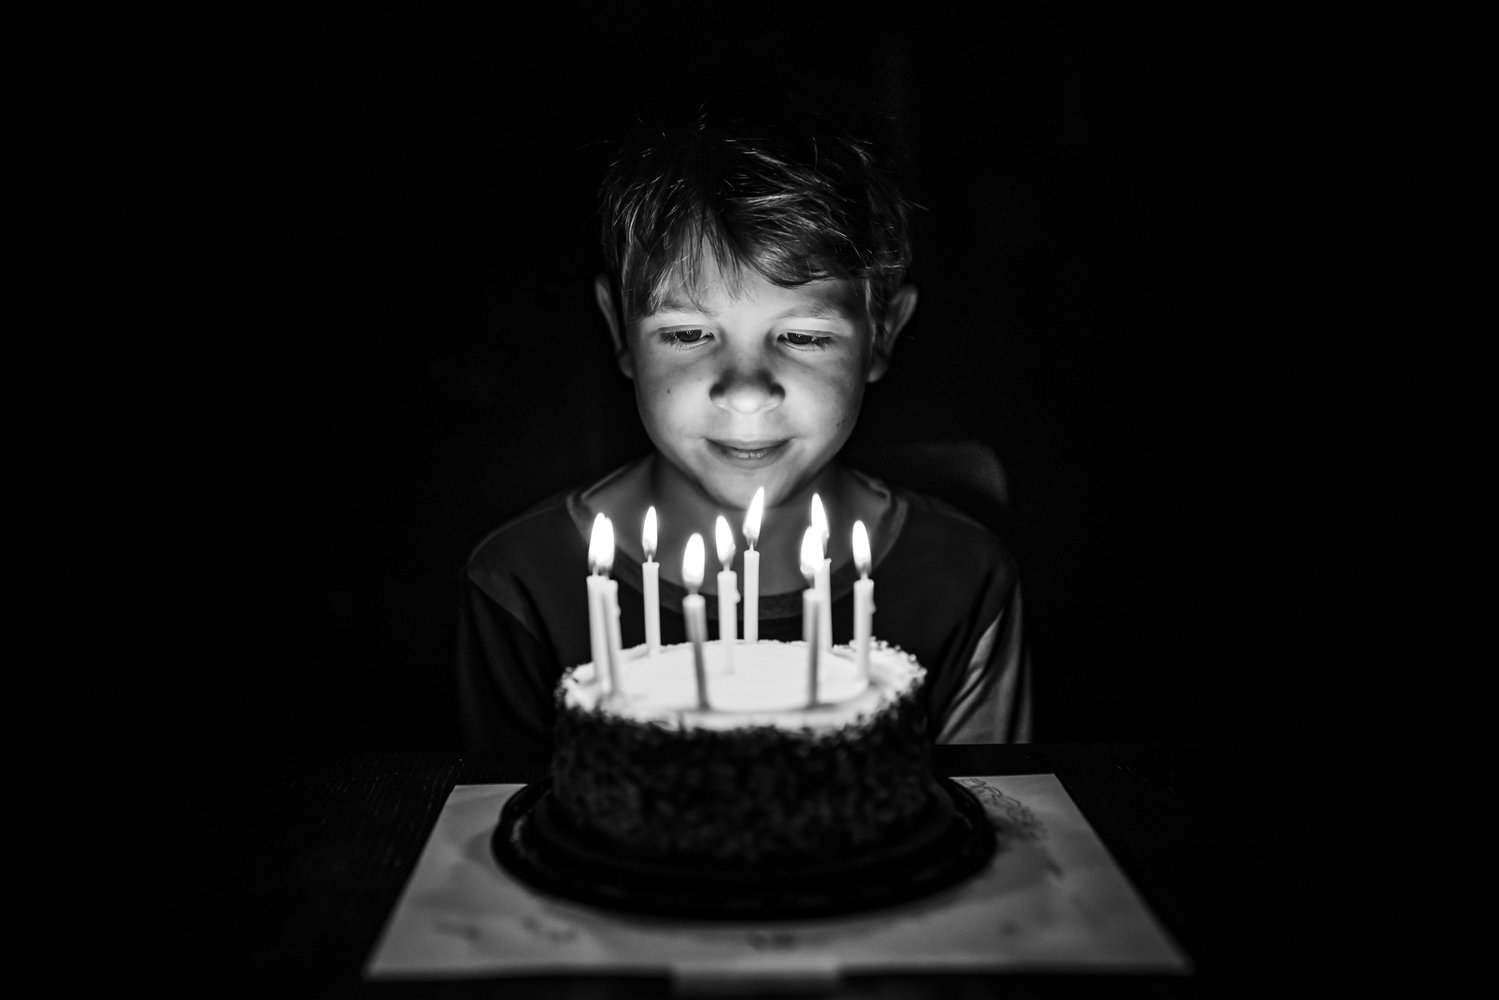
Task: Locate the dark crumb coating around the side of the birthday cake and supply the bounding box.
[552,644,938,867]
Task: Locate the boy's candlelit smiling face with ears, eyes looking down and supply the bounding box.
[601,268,898,510]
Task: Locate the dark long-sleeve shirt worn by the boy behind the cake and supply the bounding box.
[457,464,1031,763]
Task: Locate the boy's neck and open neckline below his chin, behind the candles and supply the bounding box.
[589,454,884,594]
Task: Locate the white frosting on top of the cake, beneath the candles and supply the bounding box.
[562,640,922,730]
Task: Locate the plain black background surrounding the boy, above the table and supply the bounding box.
[23,3,1495,756]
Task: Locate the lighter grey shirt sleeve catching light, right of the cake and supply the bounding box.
[931,583,1031,744]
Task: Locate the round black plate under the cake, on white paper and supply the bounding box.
[490,778,995,921]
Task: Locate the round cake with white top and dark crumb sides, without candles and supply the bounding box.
[552,642,944,867]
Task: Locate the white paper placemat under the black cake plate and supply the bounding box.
[366,774,1190,990]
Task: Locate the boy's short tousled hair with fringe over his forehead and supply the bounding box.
[600,84,911,330]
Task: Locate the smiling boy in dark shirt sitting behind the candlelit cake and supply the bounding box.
[459,89,1030,765]
